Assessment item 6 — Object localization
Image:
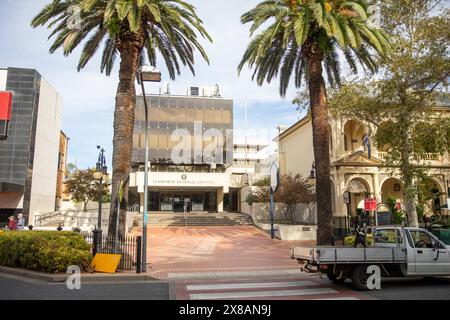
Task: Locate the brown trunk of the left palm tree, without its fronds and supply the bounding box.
[108,33,142,236]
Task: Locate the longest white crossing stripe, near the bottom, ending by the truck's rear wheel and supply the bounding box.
[189,288,338,300]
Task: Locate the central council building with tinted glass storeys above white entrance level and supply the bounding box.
[130,87,240,212]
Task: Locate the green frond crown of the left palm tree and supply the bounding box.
[31,0,211,79]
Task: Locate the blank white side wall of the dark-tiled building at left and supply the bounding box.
[30,79,62,221]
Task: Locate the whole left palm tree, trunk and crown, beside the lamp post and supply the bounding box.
[31,0,211,234]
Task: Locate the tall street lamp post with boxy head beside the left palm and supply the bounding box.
[138,66,161,273]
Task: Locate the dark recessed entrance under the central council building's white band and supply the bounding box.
[149,191,217,212]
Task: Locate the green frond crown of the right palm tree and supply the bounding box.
[239,0,390,96]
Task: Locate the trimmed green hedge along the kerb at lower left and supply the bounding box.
[0,231,92,273]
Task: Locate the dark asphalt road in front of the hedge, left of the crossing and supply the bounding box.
[0,274,170,300]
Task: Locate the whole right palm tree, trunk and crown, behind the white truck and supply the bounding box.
[238,0,390,245]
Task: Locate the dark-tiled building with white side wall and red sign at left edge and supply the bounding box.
[0,68,62,224]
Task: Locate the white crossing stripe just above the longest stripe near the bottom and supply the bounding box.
[187,281,318,291]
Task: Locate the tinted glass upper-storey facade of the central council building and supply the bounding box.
[132,95,233,172]
